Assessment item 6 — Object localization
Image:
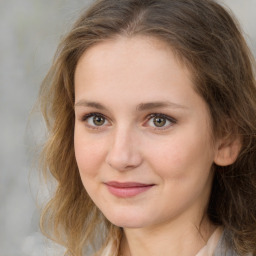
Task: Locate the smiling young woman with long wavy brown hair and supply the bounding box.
[38,0,256,256]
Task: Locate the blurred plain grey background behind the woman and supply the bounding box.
[0,0,256,256]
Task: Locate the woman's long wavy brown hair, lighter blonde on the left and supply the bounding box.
[40,0,256,256]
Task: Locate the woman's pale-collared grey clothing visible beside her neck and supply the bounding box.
[101,228,252,256]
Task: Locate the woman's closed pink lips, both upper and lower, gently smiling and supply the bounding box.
[105,181,154,198]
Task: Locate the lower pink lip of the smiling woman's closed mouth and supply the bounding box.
[104,185,153,198]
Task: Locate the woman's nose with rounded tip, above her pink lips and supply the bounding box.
[106,126,142,171]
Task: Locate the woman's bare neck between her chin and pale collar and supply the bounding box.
[121,218,216,256]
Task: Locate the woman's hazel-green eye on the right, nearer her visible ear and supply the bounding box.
[147,114,177,129]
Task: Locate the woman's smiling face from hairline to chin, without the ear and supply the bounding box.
[74,37,216,228]
